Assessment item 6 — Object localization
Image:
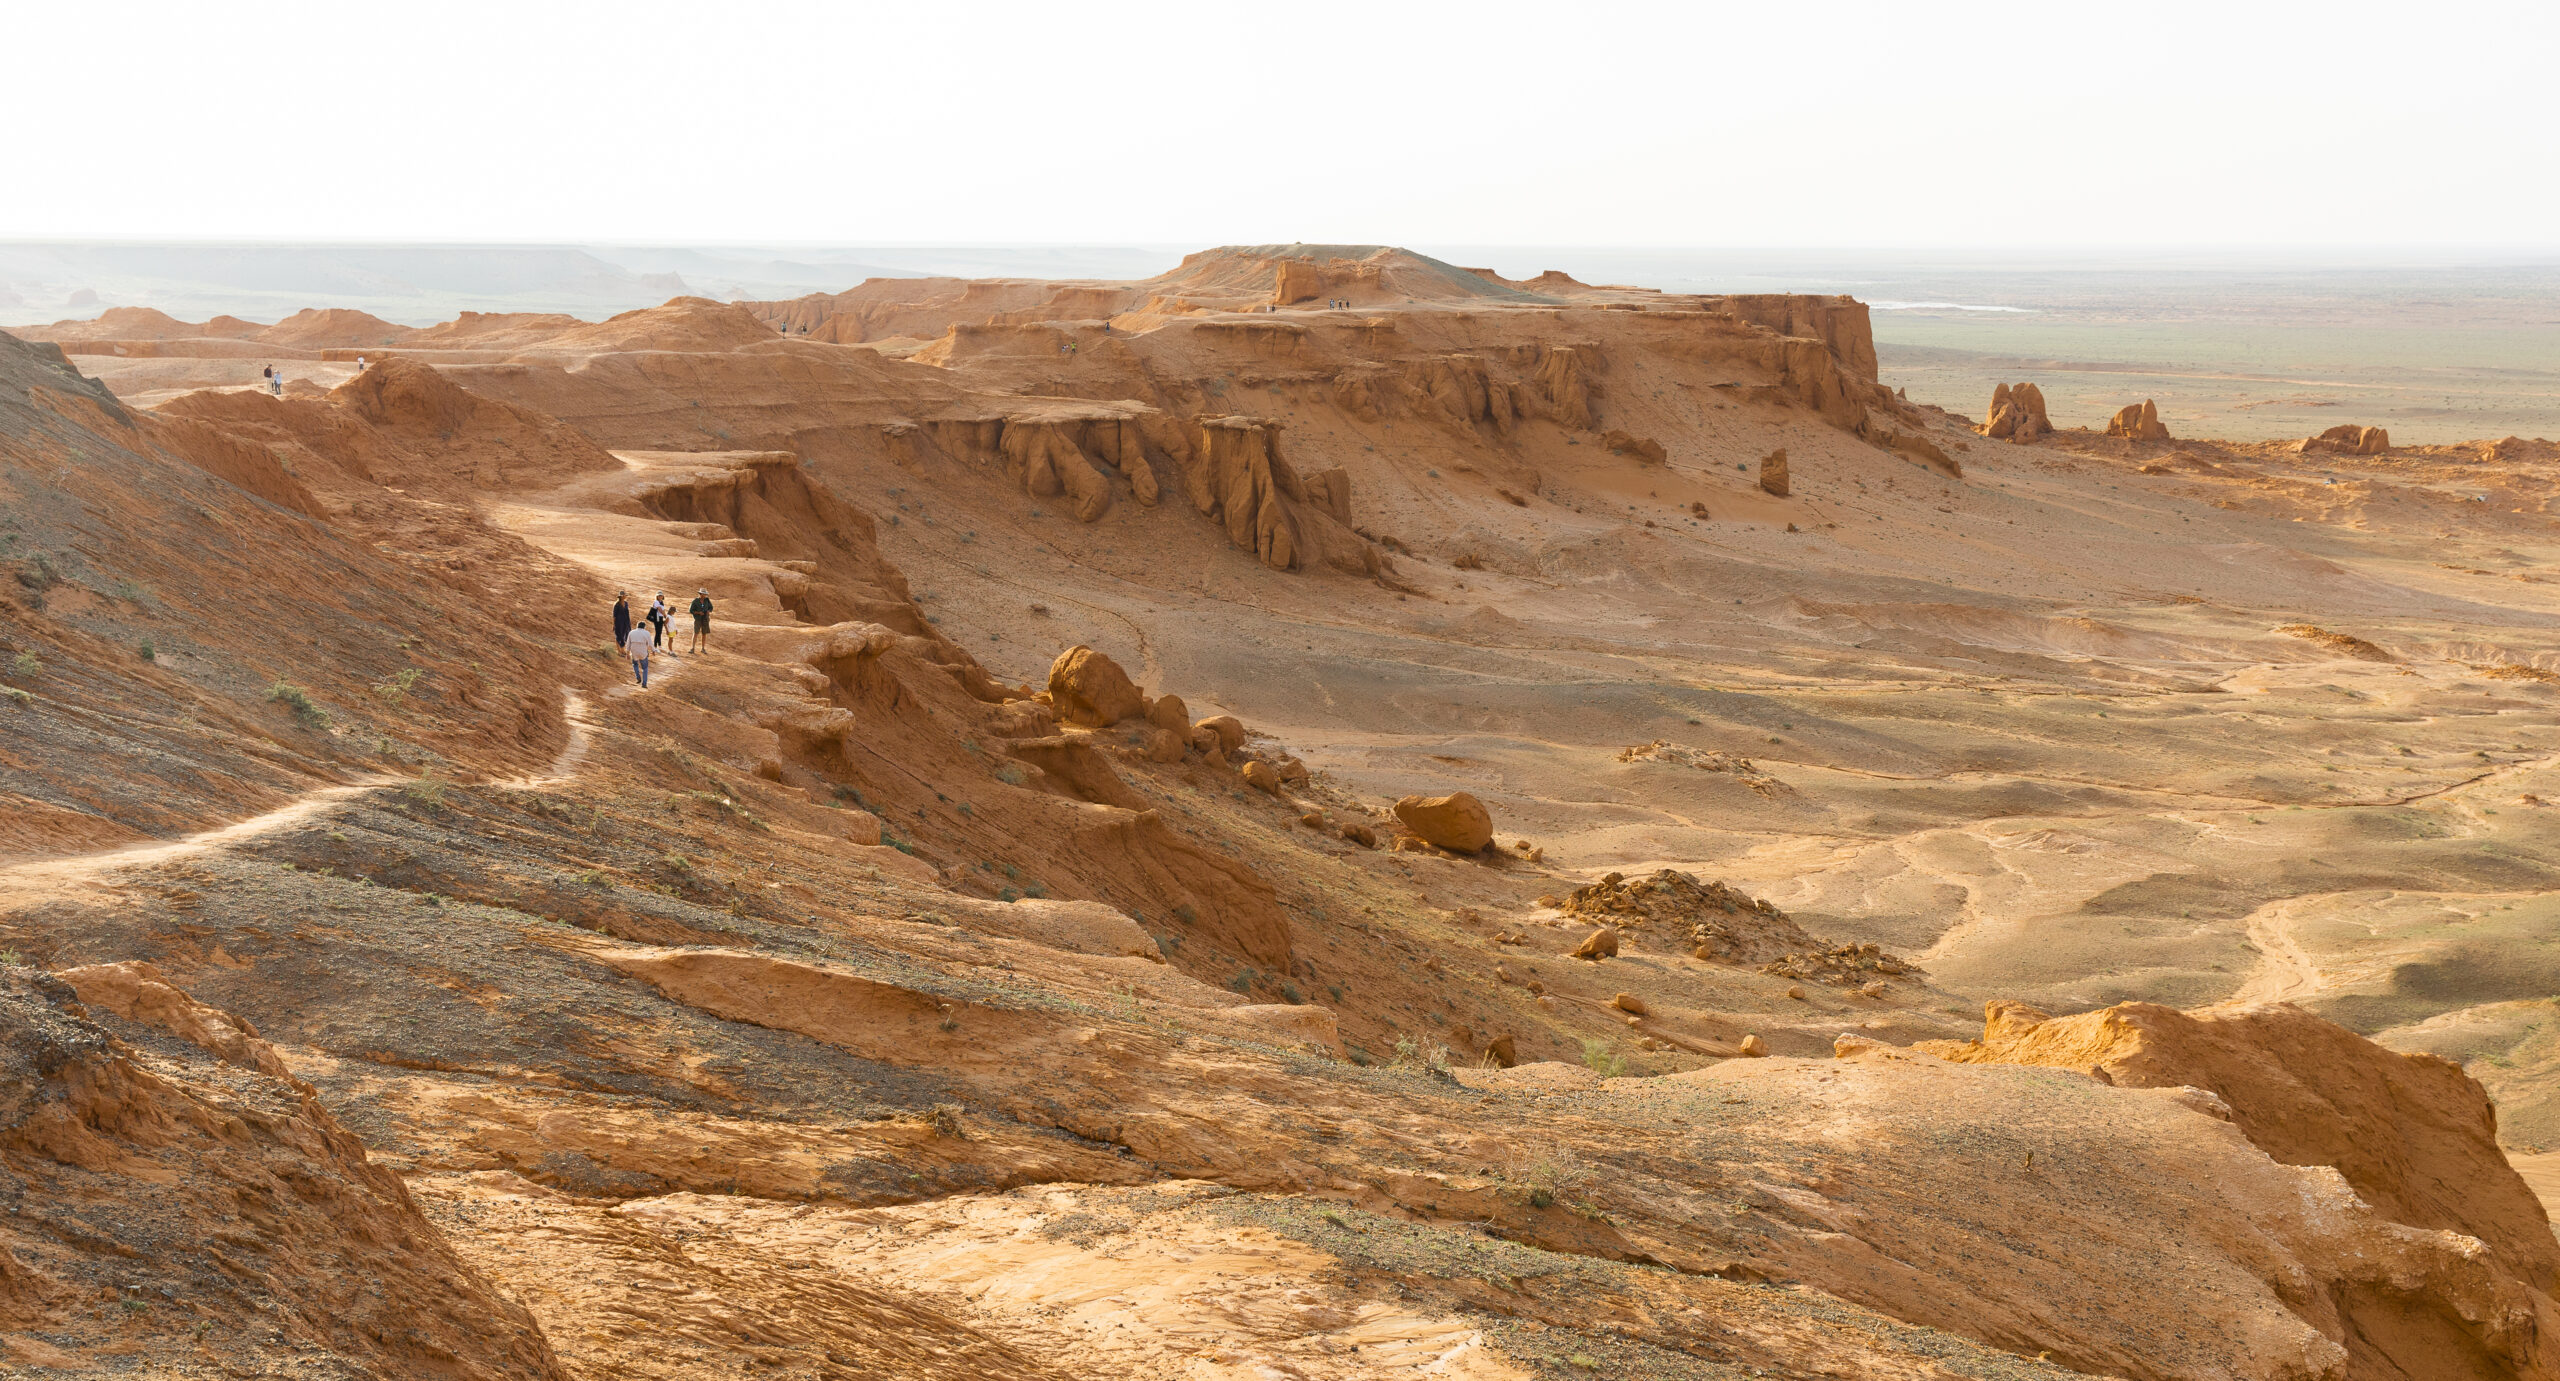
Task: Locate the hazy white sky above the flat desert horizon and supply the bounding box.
[20,0,2560,246]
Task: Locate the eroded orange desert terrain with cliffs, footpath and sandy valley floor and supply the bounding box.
[0,246,2560,1381]
